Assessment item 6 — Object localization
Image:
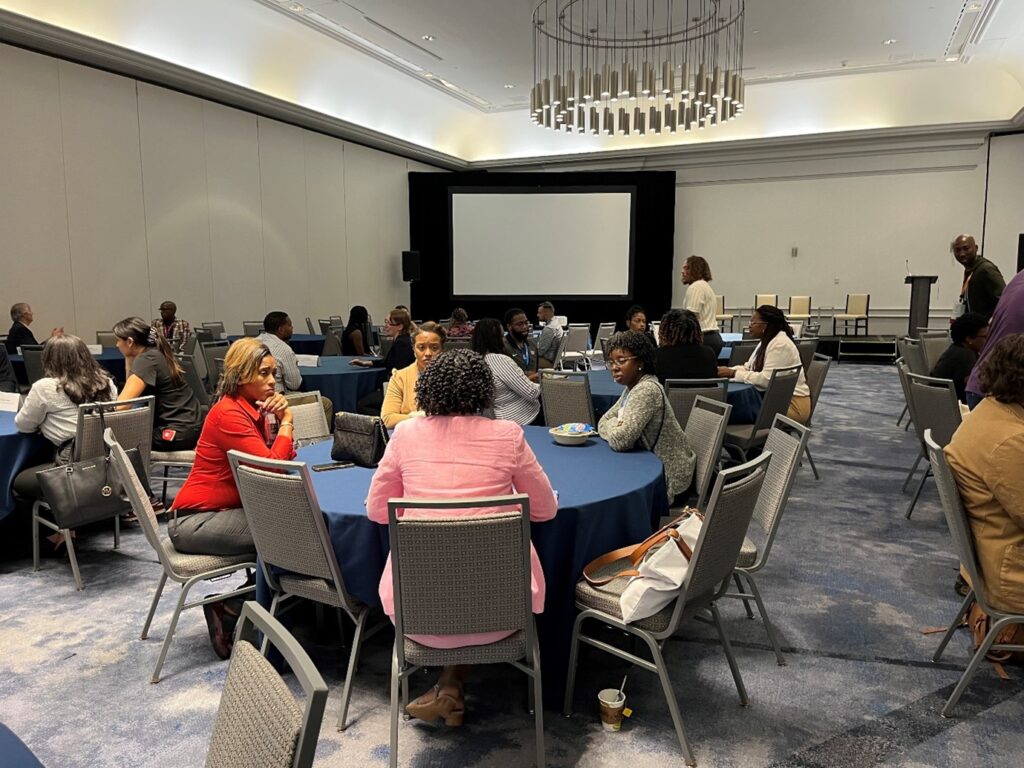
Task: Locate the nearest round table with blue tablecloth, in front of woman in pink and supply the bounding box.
[256,427,668,707]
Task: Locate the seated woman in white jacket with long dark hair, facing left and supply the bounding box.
[718,304,811,424]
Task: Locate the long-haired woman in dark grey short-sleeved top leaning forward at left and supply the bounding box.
[114,317,203,451]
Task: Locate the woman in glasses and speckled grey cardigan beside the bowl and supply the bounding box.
[597,331,696,503]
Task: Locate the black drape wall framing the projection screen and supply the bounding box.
[409,171,678,324]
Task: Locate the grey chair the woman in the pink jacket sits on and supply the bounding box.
[387,494,545,768]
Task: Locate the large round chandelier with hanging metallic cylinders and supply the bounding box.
[530,0,745,135]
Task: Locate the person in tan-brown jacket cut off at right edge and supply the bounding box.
[944,334,1024,613]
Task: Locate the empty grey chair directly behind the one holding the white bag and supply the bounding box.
[725,414,811,667]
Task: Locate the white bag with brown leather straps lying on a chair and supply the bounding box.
[584,510,703,624]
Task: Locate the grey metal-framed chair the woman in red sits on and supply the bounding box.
[103,429,256,683]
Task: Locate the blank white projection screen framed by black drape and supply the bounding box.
[452,190,633,298]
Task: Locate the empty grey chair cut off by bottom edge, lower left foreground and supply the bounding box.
[206,601,328,768]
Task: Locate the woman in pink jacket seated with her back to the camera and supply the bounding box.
[367,349,558,725]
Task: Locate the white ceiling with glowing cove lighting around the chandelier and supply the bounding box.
[0,0,1024,167]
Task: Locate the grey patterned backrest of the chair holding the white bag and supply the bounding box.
[673,451,771,614]
